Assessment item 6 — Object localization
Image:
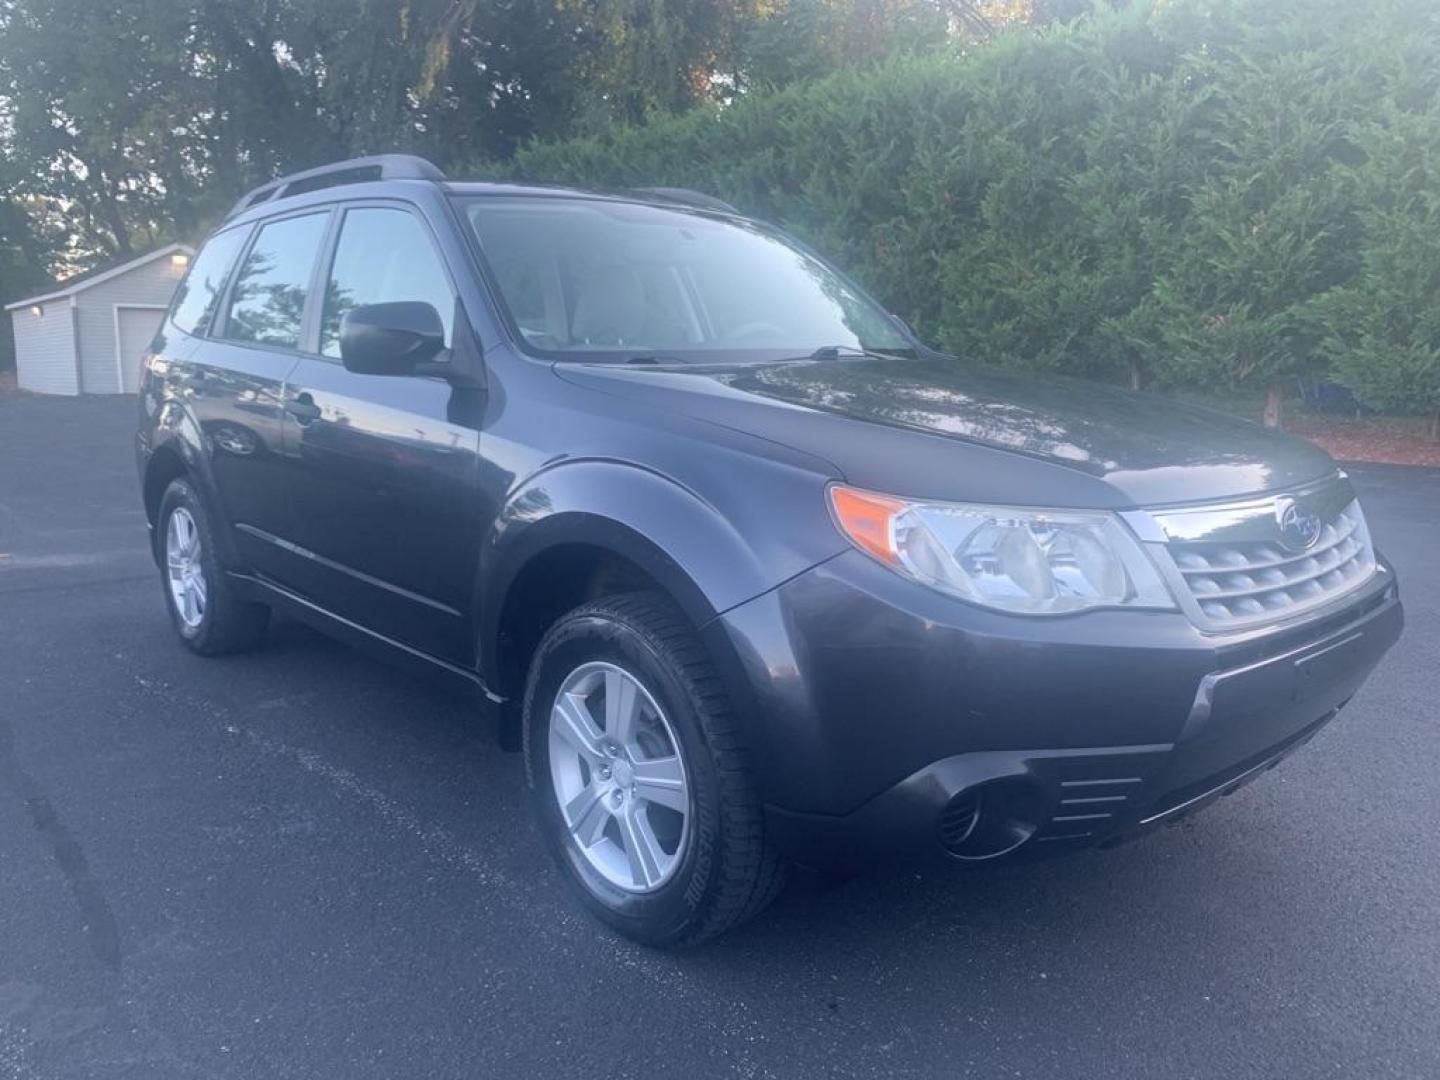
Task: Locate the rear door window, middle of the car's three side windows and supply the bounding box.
[225,213,330,348]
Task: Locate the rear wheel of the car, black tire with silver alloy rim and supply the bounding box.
[156,480,269,657]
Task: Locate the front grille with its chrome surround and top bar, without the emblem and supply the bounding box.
[1125,474,1377,631]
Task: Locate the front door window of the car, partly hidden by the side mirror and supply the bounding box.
[320,206,455,357]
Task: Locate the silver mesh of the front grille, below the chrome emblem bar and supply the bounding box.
[1165,500,1375,629]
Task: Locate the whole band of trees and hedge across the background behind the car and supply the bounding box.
[0,0,1440,426]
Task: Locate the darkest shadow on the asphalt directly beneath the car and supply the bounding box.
[259,610,1333,984]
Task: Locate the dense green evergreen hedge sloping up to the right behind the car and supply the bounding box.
[490,0,1440,432]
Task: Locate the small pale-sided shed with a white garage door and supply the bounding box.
[6,243,194,393]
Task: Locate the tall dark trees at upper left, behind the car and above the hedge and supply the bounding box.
[0,0,969,266]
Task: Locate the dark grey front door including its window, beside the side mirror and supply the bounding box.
[276,202,482,662]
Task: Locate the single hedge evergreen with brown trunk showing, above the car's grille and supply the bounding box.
[1155,11,1369,426]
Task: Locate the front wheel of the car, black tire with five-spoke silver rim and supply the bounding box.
[523,593,783,948]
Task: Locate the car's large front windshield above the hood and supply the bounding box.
[465,197,910,361]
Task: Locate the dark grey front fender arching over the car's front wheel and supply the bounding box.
[477,459,847,685]
